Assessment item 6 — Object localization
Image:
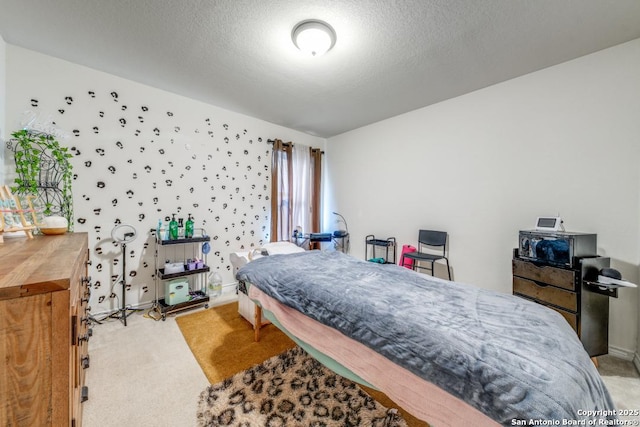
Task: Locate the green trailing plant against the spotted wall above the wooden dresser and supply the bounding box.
[10,129,73,228]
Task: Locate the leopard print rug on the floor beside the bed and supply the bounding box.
[197,347,407,427]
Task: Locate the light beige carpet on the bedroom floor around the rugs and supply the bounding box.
[83,304,640,427]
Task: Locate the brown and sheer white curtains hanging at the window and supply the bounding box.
[271,139,322,242]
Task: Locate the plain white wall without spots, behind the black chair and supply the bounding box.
[326,39,640,357]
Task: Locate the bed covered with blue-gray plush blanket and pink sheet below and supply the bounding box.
[236,251,615,426]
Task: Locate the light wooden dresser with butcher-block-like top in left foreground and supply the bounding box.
[0,233,90,427]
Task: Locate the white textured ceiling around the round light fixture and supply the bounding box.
[0,0,640,137]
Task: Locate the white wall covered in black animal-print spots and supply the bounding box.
[6,45,325,313]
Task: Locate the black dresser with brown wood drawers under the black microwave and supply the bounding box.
[512,251,610,357]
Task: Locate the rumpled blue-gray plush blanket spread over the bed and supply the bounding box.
[237,251,615,425]
